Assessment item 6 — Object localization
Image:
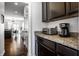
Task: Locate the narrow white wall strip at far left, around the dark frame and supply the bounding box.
[0,2,5,56]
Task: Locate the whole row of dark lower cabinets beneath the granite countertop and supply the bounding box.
[37,37,79,56]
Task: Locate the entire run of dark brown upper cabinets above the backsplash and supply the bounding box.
[42,2,79,22]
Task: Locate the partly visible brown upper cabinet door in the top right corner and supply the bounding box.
[66,2,79,14]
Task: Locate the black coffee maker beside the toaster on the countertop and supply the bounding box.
[59,23,70,37]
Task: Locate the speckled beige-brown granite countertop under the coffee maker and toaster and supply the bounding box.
[35,32,79,50]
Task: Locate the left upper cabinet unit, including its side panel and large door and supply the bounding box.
[42,2,66,21]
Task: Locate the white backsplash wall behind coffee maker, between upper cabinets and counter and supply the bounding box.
[47,17,79,33]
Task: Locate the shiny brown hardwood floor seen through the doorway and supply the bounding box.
[4,38,28,56]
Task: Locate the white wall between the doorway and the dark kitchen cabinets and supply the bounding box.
[31,2,46,55]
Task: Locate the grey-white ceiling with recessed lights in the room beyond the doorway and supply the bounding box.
[5,2,28,18]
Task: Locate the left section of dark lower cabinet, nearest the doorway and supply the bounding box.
[38,37,56,56]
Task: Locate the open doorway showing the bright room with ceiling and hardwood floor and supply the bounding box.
[4,2,28,56]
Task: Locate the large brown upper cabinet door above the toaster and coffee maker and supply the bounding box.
[47,2,66,20]
